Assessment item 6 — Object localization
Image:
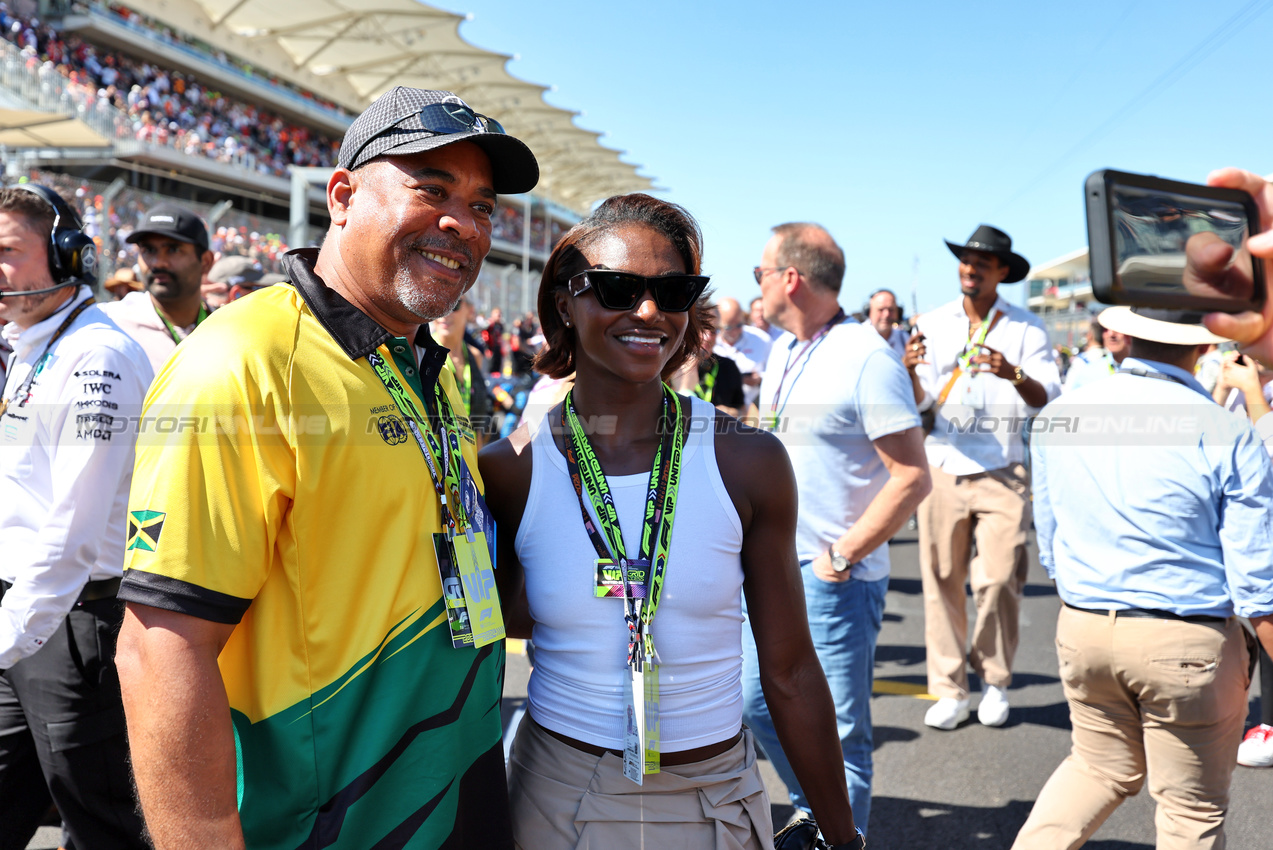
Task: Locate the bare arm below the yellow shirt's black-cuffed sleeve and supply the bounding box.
[116,602,244,850]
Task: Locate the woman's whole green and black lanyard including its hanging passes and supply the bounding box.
[561,384,685,784]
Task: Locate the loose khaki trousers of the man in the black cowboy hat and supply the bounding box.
[918,463,1030,700]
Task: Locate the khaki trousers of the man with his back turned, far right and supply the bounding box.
[1012,608,1250,850]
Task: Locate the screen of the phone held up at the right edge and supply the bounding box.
[1109,183,1255,303]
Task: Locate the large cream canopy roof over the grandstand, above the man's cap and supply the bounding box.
[129,0,652,211]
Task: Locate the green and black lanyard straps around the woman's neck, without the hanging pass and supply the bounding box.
[561,384,685,672]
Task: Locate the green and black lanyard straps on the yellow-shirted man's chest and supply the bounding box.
[367,343,474,531]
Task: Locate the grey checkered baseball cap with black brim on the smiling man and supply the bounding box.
[339,85,540,195]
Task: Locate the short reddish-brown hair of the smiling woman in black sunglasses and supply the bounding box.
[535,192,713,379]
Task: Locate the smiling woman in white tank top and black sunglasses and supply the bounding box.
[480,195,862,850]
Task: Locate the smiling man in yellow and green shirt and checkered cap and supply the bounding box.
[118,88,538,850]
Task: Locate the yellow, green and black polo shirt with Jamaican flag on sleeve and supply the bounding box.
[120,251,510,850]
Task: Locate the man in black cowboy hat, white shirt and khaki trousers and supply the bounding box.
[903,224,1060,729]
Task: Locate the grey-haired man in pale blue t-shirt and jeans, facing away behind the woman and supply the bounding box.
[742,224,931,825]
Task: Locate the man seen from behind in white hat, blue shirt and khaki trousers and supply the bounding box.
[1013,307,1273,850]
